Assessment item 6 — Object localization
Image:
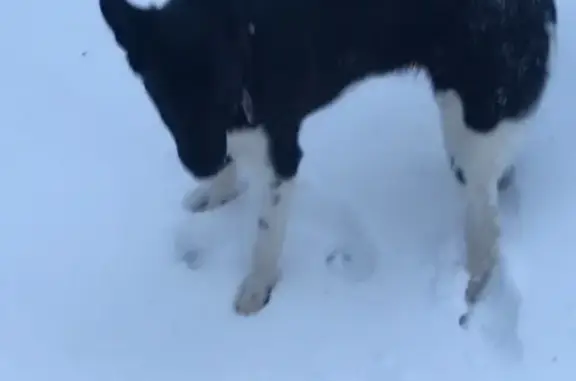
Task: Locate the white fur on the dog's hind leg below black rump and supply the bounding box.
[436,90,526,314]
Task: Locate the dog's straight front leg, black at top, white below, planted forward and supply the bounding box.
[235,123,302,315]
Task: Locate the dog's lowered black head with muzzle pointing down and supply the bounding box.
[100,0,244,175]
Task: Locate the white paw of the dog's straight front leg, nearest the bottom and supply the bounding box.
[234,273,278,316]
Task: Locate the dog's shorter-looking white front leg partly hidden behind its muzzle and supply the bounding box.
[183,157,243,212]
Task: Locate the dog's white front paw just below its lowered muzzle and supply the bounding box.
[182,181,248,213]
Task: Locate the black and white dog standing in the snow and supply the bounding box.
[99,0,557,315]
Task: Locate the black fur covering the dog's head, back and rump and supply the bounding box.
[100,0,556,183]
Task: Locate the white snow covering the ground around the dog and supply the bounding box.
[0,0,576,381]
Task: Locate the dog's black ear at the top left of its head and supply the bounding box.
[99,0,158,52]
